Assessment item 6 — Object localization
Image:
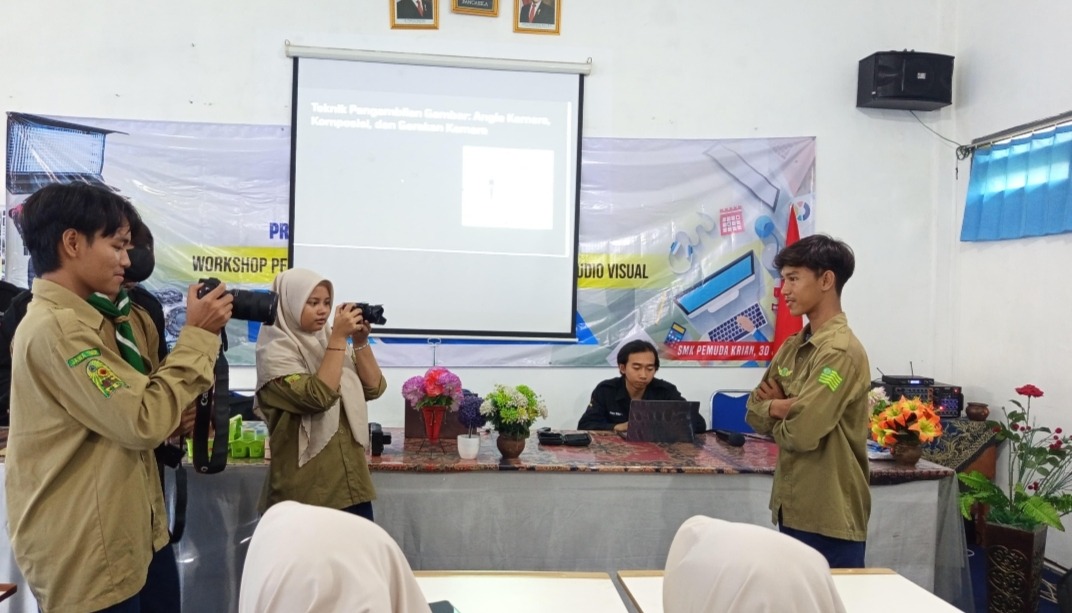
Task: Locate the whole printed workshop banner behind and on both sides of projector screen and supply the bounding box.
[0,114,815,367]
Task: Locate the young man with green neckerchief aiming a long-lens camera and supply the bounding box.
[5,184,232,613]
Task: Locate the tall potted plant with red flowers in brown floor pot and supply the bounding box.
[958,385,1072,611]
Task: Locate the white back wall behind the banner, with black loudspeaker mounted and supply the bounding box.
[0,0,953,427]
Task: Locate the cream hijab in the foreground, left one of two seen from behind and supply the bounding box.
[238,500,430,613]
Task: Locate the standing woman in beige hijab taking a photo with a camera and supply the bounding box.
[255,268,387,520]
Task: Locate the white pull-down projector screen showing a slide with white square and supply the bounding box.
[288,52,583,341]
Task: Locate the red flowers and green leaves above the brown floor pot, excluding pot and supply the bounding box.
[957,385,1072,530]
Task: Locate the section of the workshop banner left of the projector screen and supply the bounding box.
[3,113,291,364]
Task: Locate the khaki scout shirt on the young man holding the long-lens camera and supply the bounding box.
[5,279,220,613]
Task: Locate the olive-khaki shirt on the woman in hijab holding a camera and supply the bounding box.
[257,374,387,512]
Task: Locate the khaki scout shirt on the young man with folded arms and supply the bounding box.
[746,313,870,541]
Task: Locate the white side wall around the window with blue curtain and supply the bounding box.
[939,0,1072,566]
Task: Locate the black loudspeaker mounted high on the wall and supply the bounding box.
[857,51,953,110]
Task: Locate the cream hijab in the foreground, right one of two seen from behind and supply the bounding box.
[662,515,845,613]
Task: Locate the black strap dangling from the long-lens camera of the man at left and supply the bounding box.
[191,331,230,475]
